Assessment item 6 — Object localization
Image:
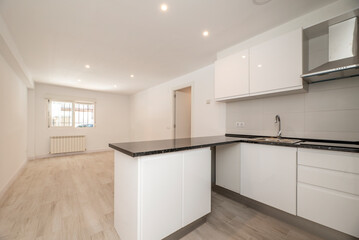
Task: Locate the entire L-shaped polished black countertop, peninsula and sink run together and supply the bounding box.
[109,134,359,157]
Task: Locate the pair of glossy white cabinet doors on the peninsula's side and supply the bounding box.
[139,148,211,240]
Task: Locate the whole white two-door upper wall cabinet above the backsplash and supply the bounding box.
[215,29,306,101]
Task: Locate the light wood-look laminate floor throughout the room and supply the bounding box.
[0,152,319,240]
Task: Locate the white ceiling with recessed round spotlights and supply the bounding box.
[0,0,334,94]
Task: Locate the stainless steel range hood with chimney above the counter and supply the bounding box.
[301,9,359,83]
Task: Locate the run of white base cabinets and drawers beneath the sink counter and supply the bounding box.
[216,143,359,238]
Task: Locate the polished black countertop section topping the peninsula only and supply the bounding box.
[109,136,245,157]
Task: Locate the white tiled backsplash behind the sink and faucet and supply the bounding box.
[226,77,359,141]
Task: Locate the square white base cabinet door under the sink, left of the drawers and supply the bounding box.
[240,143,297,214]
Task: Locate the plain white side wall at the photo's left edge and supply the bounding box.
[0,54,27,196]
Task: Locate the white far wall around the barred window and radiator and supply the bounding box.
[28,84,130,158]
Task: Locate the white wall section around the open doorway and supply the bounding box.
[130,65,225,141]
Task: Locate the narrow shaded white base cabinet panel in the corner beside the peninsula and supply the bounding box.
[216,143,241,193]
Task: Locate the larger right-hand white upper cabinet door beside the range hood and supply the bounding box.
[250,29,303,96]
